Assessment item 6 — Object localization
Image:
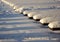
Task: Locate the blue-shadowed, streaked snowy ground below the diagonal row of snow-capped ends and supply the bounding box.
[0,0,60,42]
